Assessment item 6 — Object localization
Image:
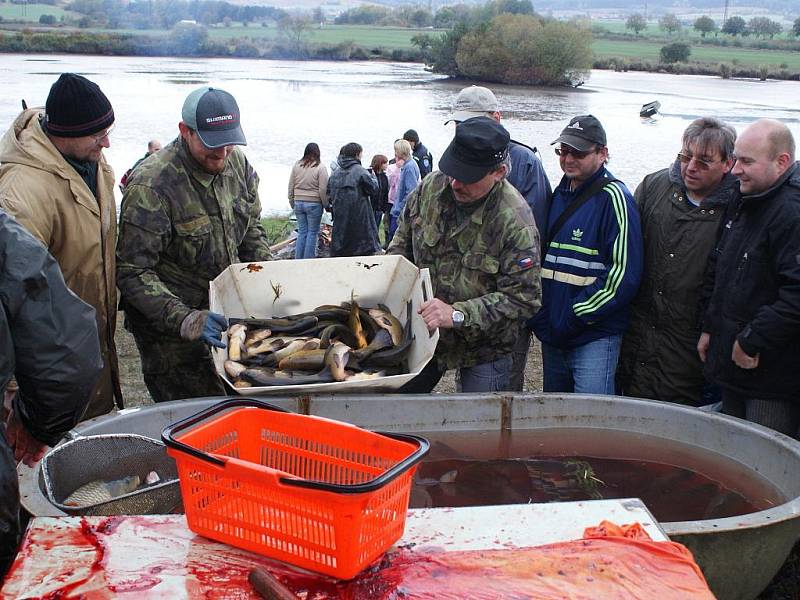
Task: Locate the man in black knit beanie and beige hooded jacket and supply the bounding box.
[0,73,122,419]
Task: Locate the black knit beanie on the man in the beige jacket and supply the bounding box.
[44,73,114,137]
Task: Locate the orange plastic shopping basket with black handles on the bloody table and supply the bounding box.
[161,399,429,579]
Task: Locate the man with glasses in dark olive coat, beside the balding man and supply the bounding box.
[617,117,739,406]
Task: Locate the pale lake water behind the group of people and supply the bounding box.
[0,54,800,213]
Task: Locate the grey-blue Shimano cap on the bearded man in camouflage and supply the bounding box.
[181,87,247,148]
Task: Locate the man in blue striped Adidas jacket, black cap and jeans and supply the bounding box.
[528,115,644,394]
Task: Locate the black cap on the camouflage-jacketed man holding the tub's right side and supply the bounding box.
[439,117,511,184]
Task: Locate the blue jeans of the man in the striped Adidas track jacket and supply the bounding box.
[542,335,622,394]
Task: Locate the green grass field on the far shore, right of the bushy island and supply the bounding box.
[592,39,800,71]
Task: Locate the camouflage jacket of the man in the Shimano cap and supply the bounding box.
[117,138,272,335]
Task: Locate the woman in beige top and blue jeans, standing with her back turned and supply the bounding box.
[289,142,328,258]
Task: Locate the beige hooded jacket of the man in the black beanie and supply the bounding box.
[0,108,122,419]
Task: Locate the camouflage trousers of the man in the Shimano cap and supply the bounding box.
[126,319,228,402]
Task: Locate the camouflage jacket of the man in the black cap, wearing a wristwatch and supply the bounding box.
[388,171,541,369]
